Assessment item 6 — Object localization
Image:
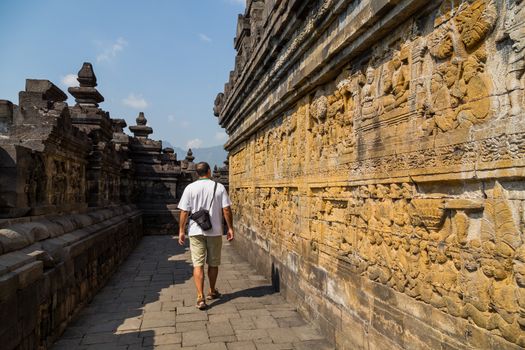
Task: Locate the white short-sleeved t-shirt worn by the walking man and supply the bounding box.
[179,179,232,236]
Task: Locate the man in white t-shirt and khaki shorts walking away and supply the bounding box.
[179,162,234,310]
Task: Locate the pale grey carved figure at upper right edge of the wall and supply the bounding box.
[497,0,525,116]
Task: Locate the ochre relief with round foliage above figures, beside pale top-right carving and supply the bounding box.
[426,0,496,133]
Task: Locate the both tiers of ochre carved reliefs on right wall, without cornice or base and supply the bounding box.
[230,0,525,346]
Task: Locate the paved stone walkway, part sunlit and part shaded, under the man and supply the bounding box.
[52,236,333,350]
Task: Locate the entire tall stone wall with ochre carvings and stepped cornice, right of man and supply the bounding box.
[214,0,525,349]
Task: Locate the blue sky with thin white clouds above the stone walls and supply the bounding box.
[0,0,245,148]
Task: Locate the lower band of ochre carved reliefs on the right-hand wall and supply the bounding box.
[232,182,525,346]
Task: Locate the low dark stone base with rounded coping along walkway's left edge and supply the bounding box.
[0,206,142,349]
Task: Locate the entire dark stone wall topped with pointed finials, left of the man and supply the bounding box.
[0,63,196,350]
